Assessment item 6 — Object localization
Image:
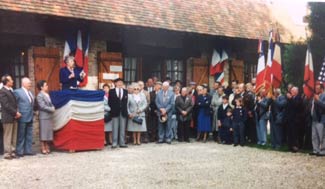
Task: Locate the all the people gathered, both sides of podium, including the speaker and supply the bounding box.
[0,57,325,159]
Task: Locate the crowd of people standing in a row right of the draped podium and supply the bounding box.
[104,77,325,156]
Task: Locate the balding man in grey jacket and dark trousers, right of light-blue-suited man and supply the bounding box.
[175,87,193,142]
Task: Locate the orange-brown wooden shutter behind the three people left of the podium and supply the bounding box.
[30,47,61,92]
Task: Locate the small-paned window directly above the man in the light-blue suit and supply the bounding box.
[166,60,184,81]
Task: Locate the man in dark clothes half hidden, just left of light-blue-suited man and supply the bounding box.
[148,81,162,142]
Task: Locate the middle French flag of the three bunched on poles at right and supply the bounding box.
[264,30,274,92]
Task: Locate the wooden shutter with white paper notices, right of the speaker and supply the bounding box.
[98,52,123,88]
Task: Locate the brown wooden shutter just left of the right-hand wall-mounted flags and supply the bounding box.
[193,58,209,85]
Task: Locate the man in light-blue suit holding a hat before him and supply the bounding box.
[156,81,175,144]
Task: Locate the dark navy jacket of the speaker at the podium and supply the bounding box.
[60,67,83,90]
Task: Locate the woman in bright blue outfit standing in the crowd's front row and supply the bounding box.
[198,86,211,142]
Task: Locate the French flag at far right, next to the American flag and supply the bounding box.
[303,47,315,98]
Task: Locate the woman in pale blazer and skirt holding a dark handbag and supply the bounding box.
[127,83,147,145]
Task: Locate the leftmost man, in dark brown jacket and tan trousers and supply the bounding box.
[0,75,21,159]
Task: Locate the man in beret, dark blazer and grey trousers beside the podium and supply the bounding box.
[108,78,128,148]
